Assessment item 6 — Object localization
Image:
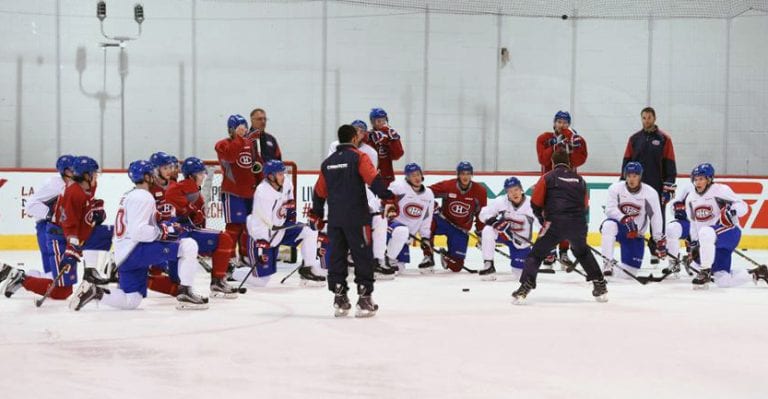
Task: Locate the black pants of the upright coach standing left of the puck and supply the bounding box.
[328,224,374,295]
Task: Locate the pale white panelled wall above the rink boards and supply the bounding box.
[0,0,768,174]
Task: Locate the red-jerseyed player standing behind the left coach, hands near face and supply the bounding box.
[366,108,405,185]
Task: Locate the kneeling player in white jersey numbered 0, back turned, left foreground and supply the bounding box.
[69,160,208,311]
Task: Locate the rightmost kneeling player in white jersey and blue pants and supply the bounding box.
[685,163,768,289]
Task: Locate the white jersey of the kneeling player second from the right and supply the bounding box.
[605,181,664,240]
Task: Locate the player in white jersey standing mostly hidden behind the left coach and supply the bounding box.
[320,119,395,276]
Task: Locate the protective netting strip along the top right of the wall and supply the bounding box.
[341,0,768,19]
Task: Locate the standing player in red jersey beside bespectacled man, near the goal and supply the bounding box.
[215,115,263,268]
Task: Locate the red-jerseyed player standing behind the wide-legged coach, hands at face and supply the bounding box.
[536,111,587,267]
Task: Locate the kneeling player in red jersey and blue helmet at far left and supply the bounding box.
[5,156,113,299]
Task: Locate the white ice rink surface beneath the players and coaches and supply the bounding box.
[0,249,768,399]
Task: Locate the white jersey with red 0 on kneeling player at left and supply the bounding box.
[114,188,162,266]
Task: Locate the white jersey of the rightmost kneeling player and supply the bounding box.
[685,183,749,241]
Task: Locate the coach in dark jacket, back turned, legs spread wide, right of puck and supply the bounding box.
[512,152,608,304]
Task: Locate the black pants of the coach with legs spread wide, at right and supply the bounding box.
[520,217,603,288]
